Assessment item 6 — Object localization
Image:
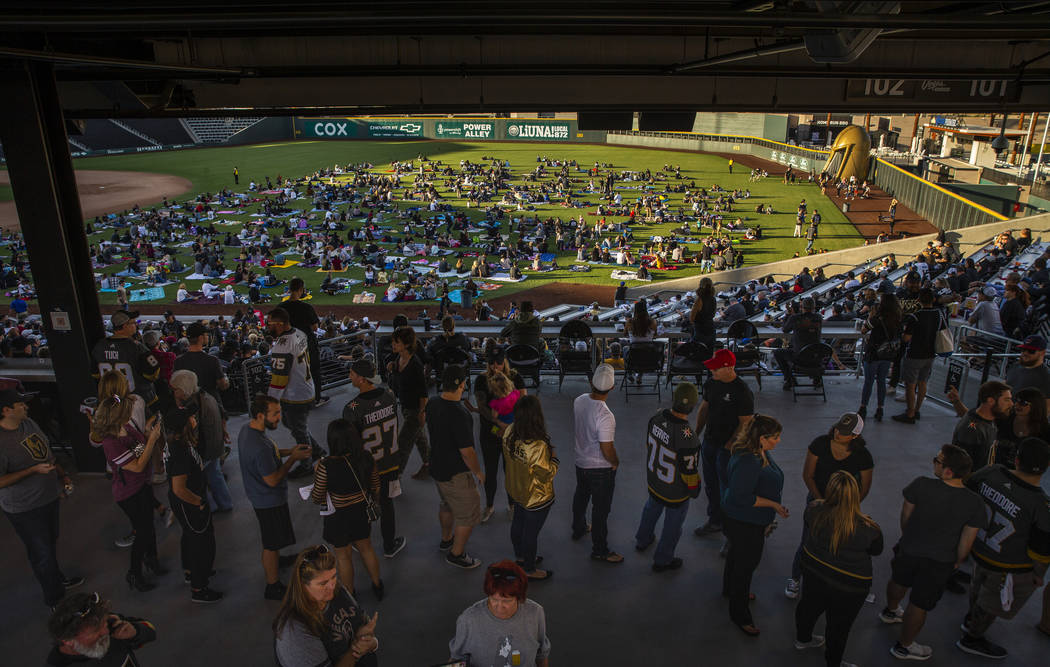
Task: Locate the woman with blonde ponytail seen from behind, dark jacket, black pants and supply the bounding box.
[795,471,883,667]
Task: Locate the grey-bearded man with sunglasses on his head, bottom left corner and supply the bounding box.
[47,592,156,667]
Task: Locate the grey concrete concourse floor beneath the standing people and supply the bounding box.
[0,378,1050,667]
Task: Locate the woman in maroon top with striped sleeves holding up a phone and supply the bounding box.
[91,388,167,591]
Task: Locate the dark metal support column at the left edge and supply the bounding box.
[0,62,104,472]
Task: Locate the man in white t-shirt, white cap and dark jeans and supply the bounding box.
[572,363,624,563]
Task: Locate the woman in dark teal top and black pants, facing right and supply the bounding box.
[721,415,789,637]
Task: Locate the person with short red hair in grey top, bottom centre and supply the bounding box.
[448,561,550,667]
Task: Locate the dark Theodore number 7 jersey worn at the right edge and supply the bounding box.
[966,465,1050,572]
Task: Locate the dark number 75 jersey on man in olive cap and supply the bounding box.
[646,410,700,505]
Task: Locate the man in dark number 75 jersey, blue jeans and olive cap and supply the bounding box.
[634,382,700,572]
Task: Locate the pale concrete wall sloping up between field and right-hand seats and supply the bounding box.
[628,213,1050,298]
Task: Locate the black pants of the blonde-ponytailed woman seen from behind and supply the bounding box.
[795,576,867,667]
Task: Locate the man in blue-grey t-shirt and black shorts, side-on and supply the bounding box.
[237,394,310,600]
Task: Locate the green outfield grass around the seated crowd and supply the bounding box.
[22,141,862,305]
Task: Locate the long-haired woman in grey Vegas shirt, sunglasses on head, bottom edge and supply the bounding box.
[273,544,379,667]
